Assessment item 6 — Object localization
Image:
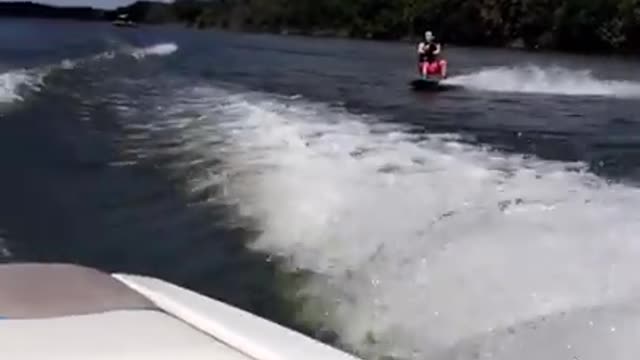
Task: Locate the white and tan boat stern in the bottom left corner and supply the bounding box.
[0,264,357,360]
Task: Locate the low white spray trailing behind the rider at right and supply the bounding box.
[447,66,640,97]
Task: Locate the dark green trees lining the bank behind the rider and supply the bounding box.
[161,0,640,52]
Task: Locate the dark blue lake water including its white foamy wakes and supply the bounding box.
[0,19,640,359]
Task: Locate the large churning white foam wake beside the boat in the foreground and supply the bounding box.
[140,88,640,360]
